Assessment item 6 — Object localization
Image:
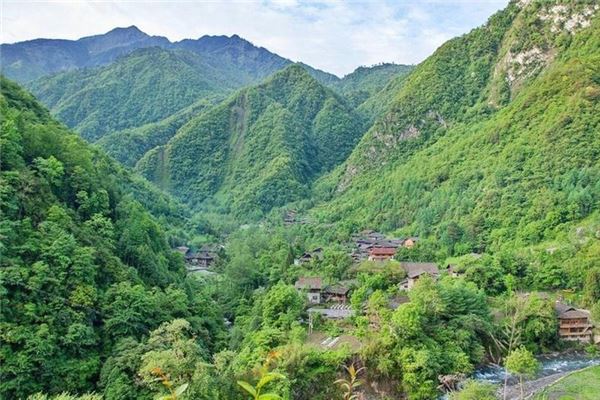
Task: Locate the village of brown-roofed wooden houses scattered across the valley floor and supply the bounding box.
[175,225,600,350]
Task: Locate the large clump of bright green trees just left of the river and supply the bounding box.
[362,278,491,399]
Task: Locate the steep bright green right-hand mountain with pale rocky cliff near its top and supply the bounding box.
[315,2,600,265]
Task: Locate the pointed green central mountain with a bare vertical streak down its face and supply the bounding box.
[136,65,363,215]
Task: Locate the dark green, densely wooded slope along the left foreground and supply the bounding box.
[0,78,222,398]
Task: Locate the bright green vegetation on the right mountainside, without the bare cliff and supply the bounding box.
[312,3,600,294]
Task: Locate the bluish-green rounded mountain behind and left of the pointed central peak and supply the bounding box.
[30,47,237,141]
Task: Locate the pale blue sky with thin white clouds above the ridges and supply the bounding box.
[0,0,508,76]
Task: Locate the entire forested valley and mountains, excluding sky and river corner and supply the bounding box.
[0,1,600,400]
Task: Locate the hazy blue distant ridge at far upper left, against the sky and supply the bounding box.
[0,26,170,83]
